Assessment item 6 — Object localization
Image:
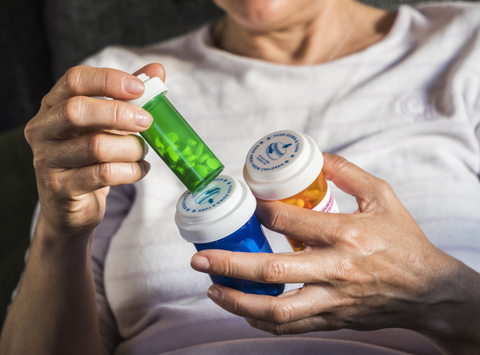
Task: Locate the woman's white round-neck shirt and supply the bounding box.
[77,3,480,355]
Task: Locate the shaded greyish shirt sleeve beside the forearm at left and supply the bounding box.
[92,185,135,354]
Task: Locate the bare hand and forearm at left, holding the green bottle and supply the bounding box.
[0,64,165,355]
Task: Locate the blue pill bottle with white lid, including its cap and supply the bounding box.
[175,175,284,296]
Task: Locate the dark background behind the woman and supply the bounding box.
[0,0,475,326]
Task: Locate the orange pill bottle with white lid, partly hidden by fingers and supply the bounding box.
[243,130,339,251]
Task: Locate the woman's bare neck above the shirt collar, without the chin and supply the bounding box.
[213,0,396,65]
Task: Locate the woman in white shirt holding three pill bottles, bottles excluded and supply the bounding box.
[0,0,480,354]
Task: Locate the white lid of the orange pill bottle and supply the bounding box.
[243,130,323,201]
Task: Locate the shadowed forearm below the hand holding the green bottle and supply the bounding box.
[0,218,101,355]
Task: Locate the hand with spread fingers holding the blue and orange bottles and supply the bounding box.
[192,154,480,351]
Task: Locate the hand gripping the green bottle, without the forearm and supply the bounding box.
[25,64,165,242]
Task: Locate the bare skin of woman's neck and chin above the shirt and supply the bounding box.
[213,0,396,65]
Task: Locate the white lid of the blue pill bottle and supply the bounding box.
[175,175,257,244]
